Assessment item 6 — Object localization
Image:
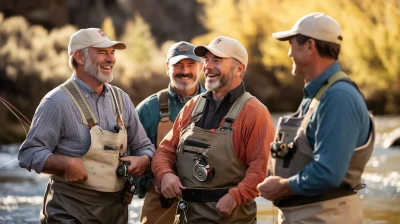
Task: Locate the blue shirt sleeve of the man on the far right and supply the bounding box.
[289,83,362,196]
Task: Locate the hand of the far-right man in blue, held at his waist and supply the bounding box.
[257,176,294,201]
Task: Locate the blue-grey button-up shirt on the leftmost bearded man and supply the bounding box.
[18,75,154,173]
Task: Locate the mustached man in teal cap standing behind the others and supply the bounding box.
[135,41,205,224]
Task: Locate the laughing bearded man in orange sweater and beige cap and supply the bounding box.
[152,36,274,223]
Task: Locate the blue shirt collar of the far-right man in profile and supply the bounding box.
[303,61,340,98]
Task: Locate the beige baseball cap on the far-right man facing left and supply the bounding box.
[272,12,343,44]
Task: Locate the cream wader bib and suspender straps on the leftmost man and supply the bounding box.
[51,79,128,192]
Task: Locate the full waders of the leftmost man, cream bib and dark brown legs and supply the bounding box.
[41,80,128,223]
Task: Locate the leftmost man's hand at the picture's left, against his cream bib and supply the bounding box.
[64,156,88,183]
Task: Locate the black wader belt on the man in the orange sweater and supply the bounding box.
[182,188,229,202]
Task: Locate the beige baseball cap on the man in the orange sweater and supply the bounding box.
[194,36,249,67]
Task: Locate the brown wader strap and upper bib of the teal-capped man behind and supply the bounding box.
[156,89,174,148]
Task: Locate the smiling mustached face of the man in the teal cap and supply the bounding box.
[167,58,201,96]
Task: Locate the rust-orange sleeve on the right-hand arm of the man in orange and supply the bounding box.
[229,101,275,205]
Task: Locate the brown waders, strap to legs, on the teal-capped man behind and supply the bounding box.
[140,89,176,224]
